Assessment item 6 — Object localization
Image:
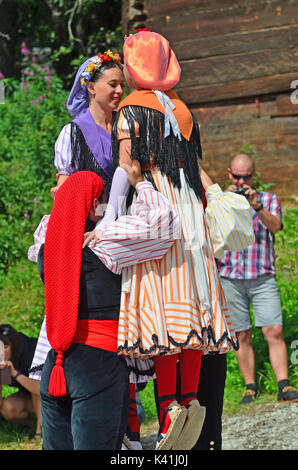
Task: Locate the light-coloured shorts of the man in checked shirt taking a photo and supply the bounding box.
[221,274,282,332]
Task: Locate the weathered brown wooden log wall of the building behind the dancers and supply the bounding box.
[122,0,298,206]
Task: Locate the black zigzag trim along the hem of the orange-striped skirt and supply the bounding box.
[117,326,239,356]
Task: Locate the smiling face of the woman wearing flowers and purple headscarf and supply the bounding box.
[88,67,124,111]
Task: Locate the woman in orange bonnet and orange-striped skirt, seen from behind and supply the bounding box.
[85,30,253,450]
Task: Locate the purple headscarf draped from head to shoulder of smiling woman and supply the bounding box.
[67,56,113,178]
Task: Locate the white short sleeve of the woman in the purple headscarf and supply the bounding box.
[54,123,73,175]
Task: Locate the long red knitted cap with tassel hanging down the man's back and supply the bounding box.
[44,171,103,397]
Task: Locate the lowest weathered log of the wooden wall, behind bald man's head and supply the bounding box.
[191,95,298,203]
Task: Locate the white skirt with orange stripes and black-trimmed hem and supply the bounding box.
[118,169,237,375]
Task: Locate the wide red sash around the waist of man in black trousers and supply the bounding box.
[73,320,119,352]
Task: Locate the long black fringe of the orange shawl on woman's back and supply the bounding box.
[112,106,203,199]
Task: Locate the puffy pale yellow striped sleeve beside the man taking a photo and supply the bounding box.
[206,184,255,259]
